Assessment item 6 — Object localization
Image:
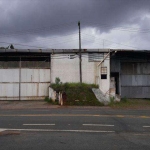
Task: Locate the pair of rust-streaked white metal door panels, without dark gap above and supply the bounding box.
[0,69,50,100]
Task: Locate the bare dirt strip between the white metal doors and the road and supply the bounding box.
[0,101,60,110]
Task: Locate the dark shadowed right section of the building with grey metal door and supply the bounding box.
[110,50,150,98]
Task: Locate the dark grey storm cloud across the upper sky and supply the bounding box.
[0,0,150,41]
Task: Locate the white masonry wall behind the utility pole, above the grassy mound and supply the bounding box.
[51,54,96,84]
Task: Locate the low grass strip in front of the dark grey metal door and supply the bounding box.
[109,98,150,109]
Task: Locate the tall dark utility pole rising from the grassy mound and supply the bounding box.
[78,21,82,83]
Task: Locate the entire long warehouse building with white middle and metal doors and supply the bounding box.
[0,49,150,100]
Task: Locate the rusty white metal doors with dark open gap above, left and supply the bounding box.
[0,54,50,100]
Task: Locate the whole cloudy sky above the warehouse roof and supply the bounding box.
[0,0,150,50]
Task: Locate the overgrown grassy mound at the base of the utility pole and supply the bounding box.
[51,83,103,106]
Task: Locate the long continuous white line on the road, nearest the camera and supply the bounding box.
[0,129,115,133]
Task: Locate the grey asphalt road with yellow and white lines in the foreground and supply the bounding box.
[0,107,150,150]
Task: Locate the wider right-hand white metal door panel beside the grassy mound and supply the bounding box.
[20,69,50,100]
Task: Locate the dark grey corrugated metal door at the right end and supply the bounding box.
[121,62,150,98]
